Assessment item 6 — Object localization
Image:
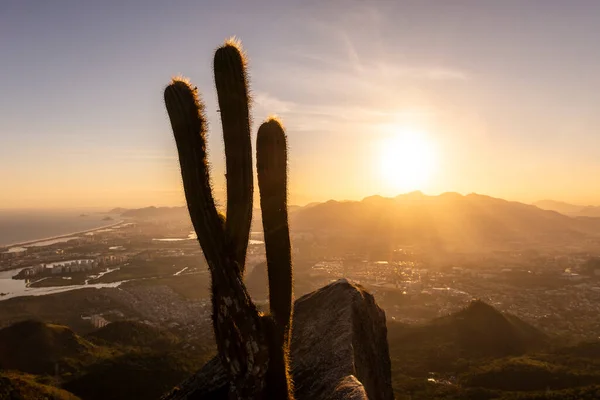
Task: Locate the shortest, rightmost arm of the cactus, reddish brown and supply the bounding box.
[256,118,292,329]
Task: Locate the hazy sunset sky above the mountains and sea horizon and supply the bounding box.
[0,0,600,209]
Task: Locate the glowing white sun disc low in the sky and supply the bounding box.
[379,128,437,193]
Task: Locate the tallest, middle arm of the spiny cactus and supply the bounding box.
[214,40,253,273]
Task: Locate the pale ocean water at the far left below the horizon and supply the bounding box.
[0,210,118,246]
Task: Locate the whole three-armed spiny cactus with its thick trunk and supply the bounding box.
[165,41,293,400]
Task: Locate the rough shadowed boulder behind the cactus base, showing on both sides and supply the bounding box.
[163,279,394,400]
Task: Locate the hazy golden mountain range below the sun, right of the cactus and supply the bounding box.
[291,192,600,251]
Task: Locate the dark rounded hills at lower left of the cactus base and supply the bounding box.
[0,321,214,400]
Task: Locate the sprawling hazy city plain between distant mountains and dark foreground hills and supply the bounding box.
[0,206,600,339]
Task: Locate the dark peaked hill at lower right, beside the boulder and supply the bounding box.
[388,301,600,400]
